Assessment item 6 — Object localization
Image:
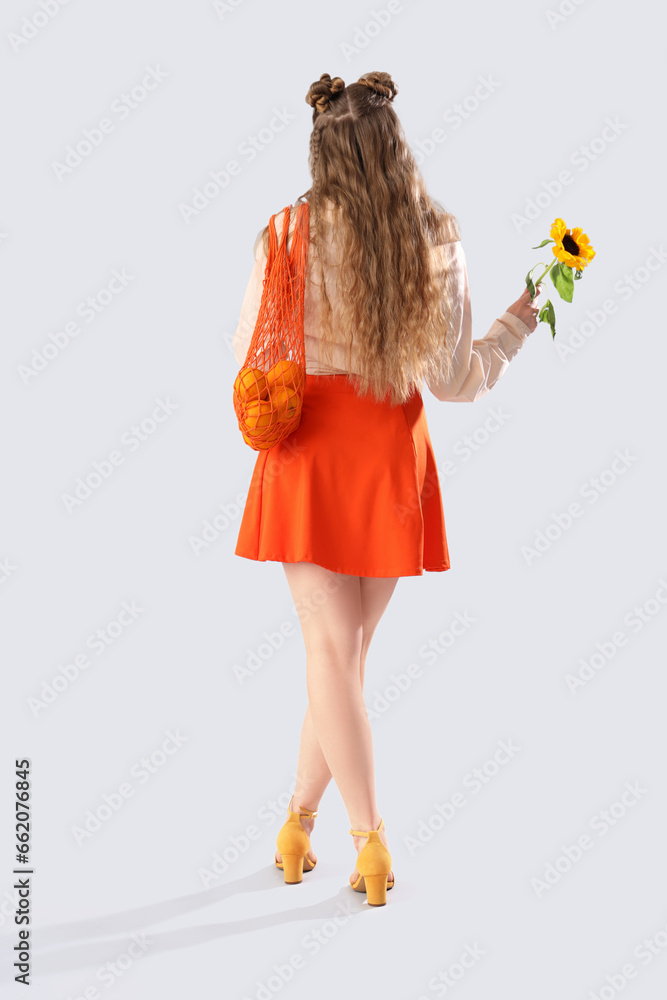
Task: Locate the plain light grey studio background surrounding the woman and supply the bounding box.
[0,0,667,1000]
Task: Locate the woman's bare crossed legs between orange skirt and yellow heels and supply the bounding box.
[277,563,398,876]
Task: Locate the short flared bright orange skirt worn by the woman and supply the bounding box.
[235,373,449,577]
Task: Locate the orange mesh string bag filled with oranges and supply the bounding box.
[234,203,309,451]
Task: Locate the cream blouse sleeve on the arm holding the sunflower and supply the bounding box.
[426,240,531,403]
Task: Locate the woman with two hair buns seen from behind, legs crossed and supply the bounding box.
[234,73,541,905]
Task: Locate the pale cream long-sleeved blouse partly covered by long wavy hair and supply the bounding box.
[233,219,531,403]
